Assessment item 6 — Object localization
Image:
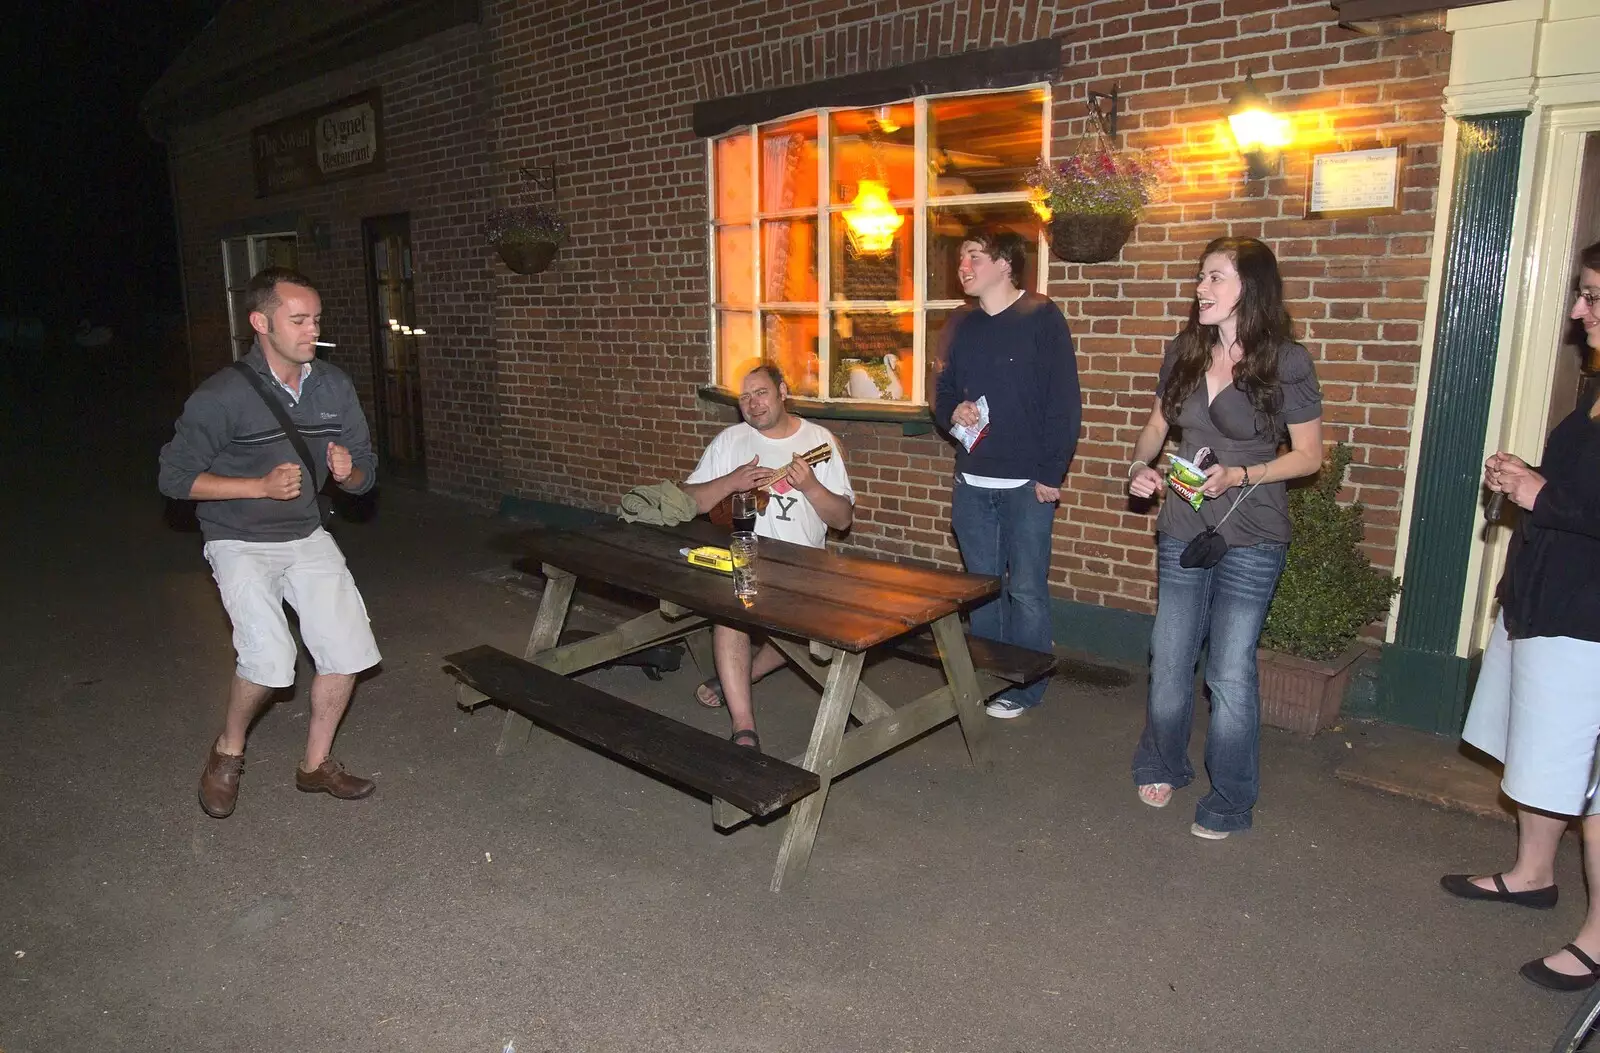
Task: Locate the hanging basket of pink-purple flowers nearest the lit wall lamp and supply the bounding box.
[1027,142,1165,262]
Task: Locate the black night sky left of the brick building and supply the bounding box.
[0,0,222,331]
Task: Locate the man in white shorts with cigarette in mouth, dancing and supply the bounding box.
[160,267,379,819]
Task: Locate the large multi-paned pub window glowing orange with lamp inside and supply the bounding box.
[709,85,1050,410]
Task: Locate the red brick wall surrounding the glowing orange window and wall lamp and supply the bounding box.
[485,0,1450,611]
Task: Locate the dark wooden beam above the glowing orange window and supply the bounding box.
[694,37,1061,138]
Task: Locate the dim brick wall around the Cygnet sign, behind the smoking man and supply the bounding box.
[168,26,502,501]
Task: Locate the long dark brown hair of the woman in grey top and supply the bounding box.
[1162,238,1291,424]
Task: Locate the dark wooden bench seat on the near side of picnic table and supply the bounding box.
[445,647,821,816]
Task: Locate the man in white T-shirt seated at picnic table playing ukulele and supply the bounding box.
[683,365,856,749]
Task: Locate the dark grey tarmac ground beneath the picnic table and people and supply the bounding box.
[0,355,1584,1053]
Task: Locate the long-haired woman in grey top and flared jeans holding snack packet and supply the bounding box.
[1128,238,1322,840]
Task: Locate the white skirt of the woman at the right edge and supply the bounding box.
[1461,615,1600,815]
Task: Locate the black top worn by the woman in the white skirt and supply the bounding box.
[1499,389,1600,642]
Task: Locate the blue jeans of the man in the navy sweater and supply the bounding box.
[950,475,1056,706]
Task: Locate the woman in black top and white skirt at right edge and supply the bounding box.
[1440,242,1600,991]
